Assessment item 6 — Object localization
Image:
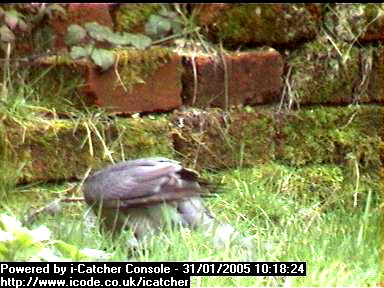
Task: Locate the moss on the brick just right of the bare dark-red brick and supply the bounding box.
[288,37,360,104]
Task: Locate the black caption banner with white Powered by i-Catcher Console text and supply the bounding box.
[0,262,306,287]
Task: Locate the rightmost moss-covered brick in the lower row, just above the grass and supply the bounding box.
[276,105,384,171]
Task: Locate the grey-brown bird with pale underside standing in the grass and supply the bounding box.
[83,157,214,239]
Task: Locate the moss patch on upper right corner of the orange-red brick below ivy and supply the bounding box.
[115,47,173,89]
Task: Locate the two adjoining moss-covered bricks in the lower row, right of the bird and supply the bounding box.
[173,106,384,175]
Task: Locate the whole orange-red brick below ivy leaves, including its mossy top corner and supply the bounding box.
[83,47,183,114]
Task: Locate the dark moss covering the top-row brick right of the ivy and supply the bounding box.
[204,4,319,47]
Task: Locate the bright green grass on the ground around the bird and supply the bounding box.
[1,163,380,287]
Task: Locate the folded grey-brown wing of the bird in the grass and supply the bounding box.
[85,160,201,208]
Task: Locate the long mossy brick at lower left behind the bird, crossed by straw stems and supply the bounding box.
[0,117,173,183]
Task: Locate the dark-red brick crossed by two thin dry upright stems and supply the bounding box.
[182,49,283,108]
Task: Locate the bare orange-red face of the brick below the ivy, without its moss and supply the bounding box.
[85,55,182,114]
